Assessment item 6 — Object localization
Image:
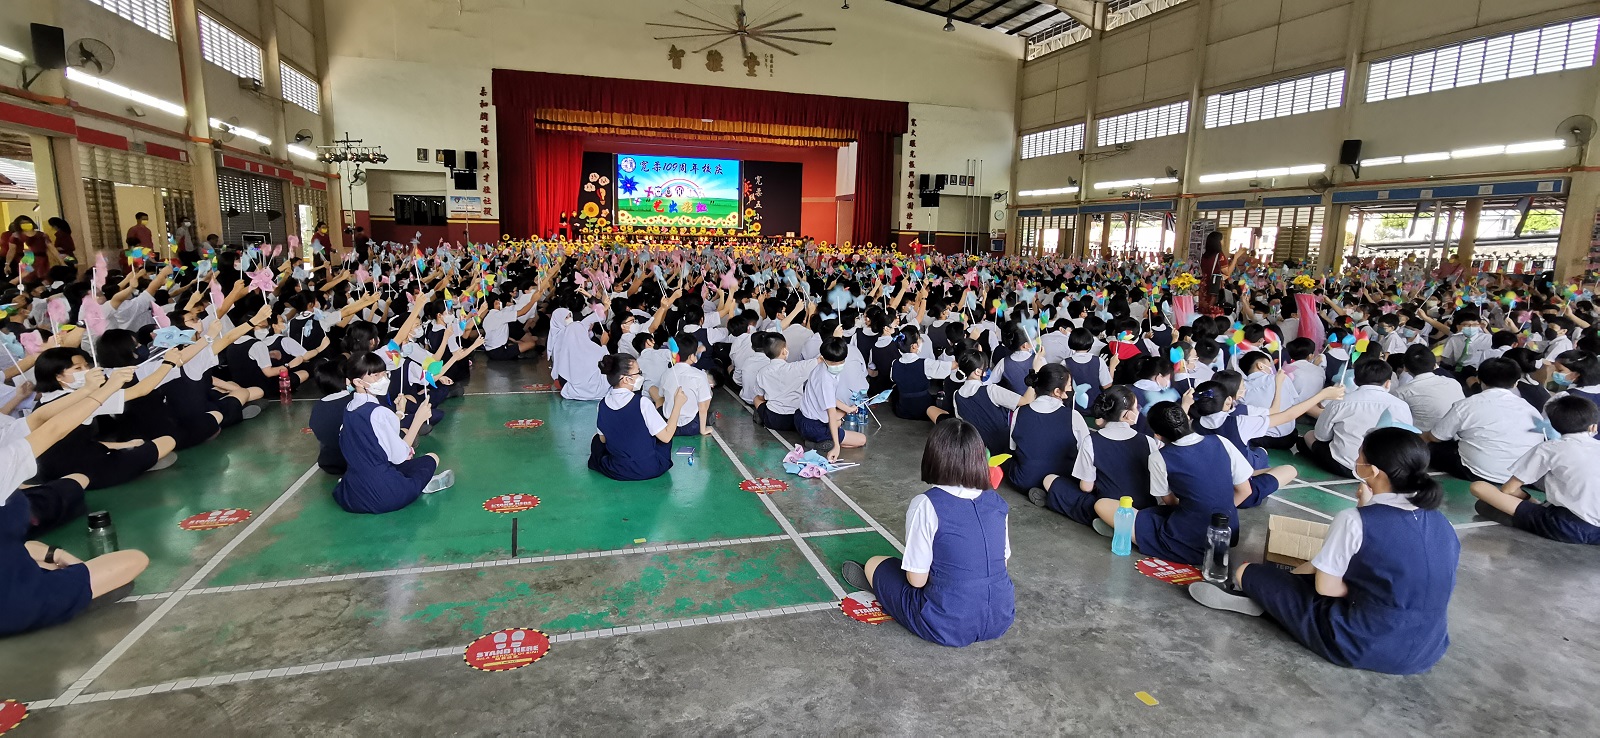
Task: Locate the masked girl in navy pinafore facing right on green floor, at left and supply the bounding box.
[324,348,456,514]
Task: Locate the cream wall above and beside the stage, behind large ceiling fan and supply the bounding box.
[326,0,1022,216]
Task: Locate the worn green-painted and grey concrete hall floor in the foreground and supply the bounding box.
[0,356,1600,729]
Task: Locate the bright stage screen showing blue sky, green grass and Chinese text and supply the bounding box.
[613,154,744,229]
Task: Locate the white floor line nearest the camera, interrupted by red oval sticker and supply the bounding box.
[27,596,843,711]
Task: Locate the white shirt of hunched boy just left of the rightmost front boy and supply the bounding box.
[1434,383,1544,485]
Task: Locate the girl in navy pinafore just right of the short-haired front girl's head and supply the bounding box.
[1002,363,1090,495]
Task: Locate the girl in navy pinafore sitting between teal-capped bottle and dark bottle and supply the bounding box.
[1094,402,1254,565]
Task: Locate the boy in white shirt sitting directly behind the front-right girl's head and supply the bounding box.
[1298,357,1411,477]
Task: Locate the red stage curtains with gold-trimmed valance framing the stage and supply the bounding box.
[493,69,909,245]
